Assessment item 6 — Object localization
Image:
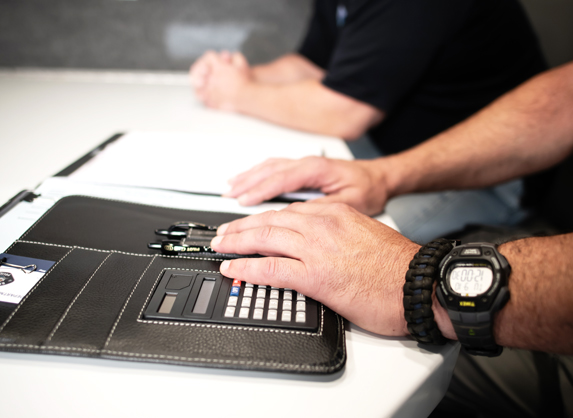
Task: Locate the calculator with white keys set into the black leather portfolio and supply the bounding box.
[143,270,319,332]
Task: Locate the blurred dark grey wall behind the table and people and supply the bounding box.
[0,0,573,71]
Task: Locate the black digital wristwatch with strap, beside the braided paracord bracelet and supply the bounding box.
[436,242,511,357]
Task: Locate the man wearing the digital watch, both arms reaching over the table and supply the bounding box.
[211,63,573,417]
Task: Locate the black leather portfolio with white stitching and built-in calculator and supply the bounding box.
[0,196,346,374]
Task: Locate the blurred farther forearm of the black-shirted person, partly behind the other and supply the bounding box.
[251,54,325,84]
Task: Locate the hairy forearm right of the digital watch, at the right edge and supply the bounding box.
[494,234,573,354]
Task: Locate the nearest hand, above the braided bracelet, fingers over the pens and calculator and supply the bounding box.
[211,203,420,336]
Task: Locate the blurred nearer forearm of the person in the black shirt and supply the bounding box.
[232,80,382,140]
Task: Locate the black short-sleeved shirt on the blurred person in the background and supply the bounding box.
[299,0,546,154]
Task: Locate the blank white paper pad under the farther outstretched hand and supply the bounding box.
[70,131,324,195]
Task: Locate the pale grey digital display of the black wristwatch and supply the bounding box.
[448,264,493,297]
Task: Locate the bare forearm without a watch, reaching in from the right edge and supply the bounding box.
[385,64,573,196]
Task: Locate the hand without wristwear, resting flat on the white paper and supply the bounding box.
[225,157,389,215]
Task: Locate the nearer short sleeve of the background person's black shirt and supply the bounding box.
[323,0,479,111]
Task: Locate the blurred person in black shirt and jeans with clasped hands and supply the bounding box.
[190,0,546,241]
